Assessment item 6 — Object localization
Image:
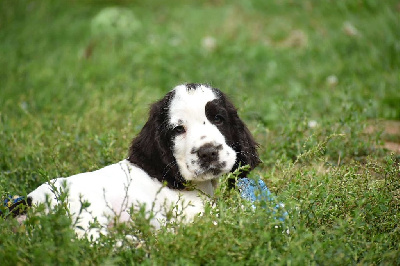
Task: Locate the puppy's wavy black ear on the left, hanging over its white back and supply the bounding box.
[128,91,185,189]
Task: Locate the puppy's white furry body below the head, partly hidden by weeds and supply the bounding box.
[28,160,208,239]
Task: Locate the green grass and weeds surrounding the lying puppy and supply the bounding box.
[0,0,400,265]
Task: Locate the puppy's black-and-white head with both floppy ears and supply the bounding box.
[128,84,260,189]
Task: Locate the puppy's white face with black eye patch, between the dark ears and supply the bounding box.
[169,85,237,181]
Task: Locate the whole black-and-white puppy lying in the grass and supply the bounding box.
[28,84,260,238]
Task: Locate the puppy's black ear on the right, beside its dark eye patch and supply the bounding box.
[221,93,261,177]
